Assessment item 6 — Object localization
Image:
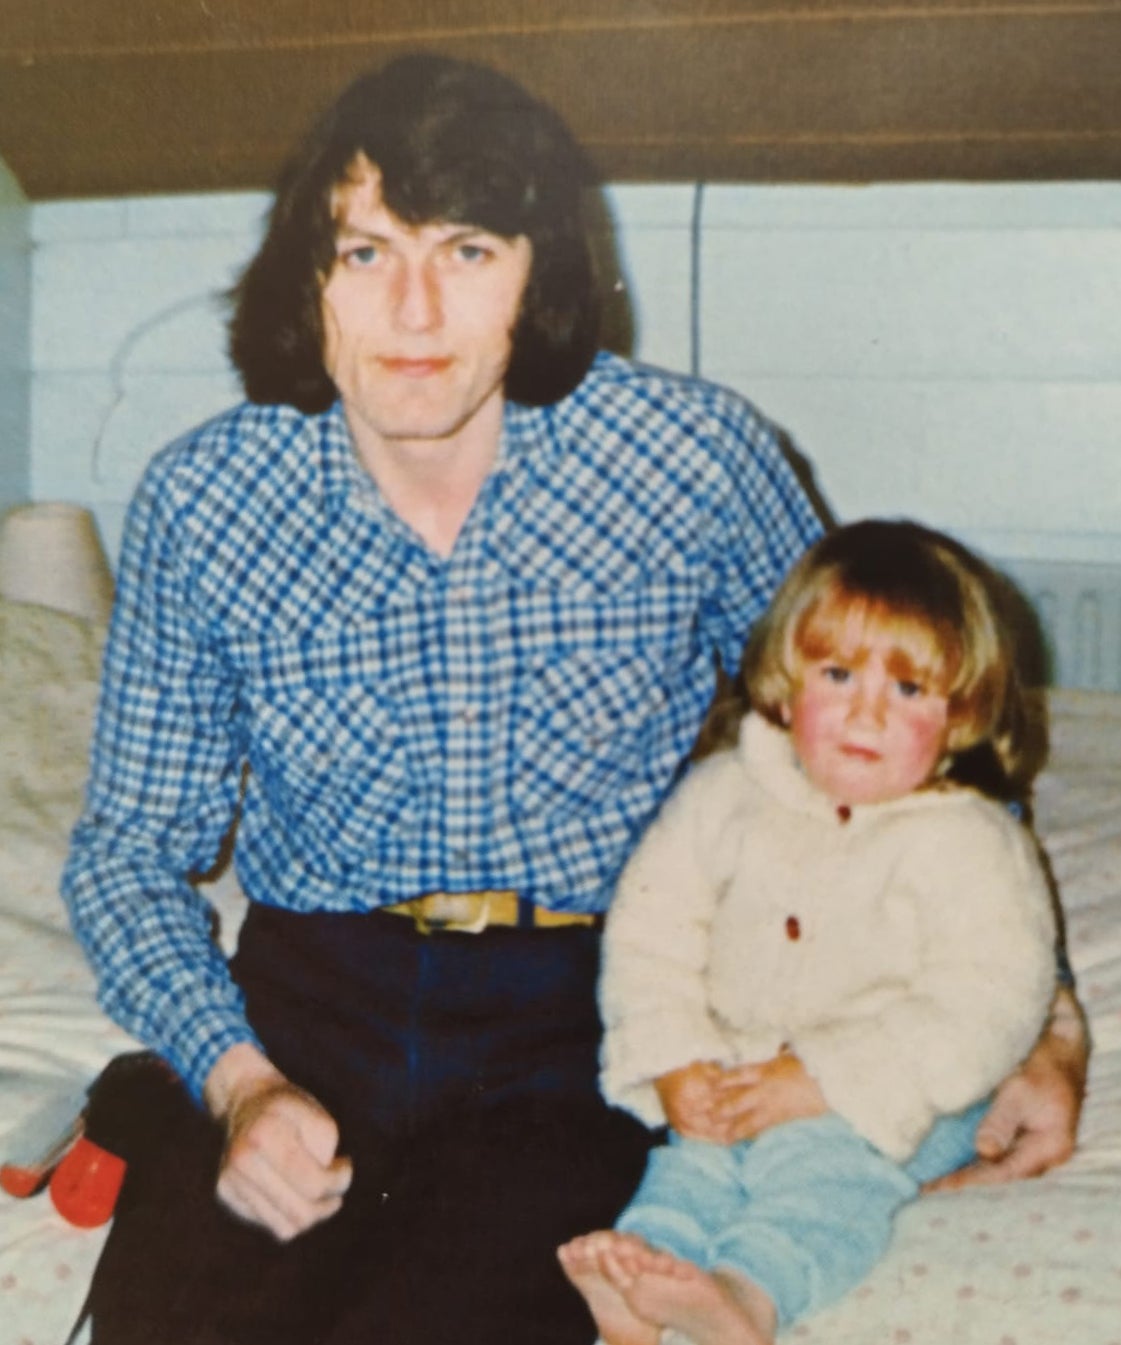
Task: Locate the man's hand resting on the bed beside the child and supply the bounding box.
[926,990,1090,1190]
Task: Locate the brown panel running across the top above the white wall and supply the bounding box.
[0,0,1121,200]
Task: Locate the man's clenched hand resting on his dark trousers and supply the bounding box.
[203,1044,353,1241]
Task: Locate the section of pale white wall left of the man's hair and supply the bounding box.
[31,194,268,555]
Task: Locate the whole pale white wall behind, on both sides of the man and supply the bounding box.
[21,183,1121,562]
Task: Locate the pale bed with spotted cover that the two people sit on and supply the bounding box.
[0,600,1121,1345]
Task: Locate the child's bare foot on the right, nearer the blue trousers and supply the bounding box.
[624,1250,775,1345]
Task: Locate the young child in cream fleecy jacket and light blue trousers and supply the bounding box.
[558,521,1055,1345]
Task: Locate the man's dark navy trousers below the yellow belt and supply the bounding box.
[92,907,650,1345]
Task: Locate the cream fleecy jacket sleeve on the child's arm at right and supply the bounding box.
[793,806,1055,1158]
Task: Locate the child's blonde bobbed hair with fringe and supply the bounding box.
[744,519,1039,787]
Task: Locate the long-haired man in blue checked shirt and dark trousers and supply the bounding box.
[63,56,1085,1345]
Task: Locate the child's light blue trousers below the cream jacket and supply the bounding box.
[616,1102,988,1326]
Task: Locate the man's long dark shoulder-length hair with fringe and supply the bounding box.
[230,55,600,413]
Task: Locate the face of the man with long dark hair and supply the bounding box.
[323,160,532,452]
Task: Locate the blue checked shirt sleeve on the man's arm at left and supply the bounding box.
[62,455,262,1096]
